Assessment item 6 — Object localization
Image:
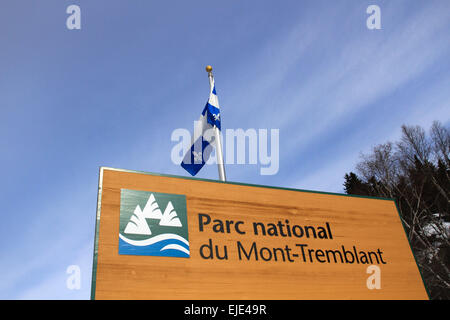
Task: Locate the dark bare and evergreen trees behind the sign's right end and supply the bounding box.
[344,121,450,299]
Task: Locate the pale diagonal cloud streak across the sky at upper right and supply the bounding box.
[283,0,450,149]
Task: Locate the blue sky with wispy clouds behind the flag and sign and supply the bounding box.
[0,0,450,299]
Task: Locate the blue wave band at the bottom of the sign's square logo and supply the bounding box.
[119,238,190,258]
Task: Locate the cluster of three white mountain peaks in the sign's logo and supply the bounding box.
[124,193,183,235]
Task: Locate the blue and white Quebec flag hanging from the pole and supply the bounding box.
[181,78,220,176]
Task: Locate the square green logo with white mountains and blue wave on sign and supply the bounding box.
[119,189,190,258]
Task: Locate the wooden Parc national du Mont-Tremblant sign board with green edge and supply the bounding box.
[92,168,428,300]
